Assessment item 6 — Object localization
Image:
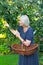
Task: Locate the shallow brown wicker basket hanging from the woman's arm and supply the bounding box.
[11,44,38,55]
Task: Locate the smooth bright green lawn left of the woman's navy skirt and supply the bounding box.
[0,54,18,65]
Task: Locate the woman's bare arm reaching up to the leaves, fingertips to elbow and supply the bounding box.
[5,23,31,46]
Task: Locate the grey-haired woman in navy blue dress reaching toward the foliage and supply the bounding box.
[5,15,39,65]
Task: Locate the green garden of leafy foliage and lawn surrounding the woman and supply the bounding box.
[0,0,43,65]
